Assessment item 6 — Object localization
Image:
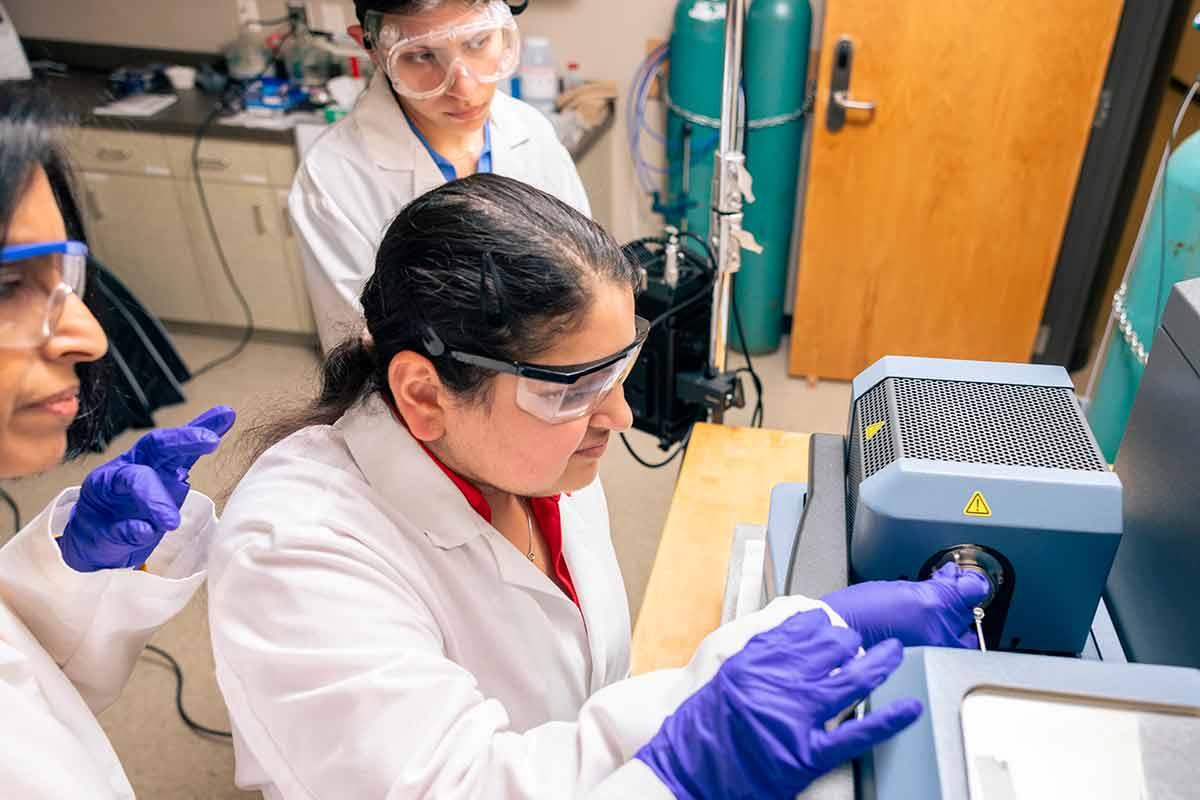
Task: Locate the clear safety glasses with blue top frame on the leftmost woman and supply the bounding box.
[0,241,88,348]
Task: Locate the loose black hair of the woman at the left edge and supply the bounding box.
[0,84,109,458]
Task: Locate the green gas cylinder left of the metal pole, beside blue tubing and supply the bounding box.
[664,0,725,240]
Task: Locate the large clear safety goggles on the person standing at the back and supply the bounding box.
[364,0,521,100]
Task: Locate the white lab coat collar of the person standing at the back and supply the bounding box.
[353,70,530,181]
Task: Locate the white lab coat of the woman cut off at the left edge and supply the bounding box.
[0,489,216,800]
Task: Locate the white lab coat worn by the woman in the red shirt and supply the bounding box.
[209,397,840,800]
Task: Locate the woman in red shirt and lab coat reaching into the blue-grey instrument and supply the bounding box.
[209,175,988,800]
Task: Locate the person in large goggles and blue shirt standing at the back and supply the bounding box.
[288,0,590,351]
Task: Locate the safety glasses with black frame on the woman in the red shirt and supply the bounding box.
[425,317,650,425]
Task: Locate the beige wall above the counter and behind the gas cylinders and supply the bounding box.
[4,0,824,241]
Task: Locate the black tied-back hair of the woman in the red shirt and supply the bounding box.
[241,174,640,457]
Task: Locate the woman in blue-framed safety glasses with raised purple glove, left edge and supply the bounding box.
[0,86,234,800]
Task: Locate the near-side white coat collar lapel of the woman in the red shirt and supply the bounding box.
[334,395,494,549]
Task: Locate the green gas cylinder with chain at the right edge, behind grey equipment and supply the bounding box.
[1087,127,1200,463]
